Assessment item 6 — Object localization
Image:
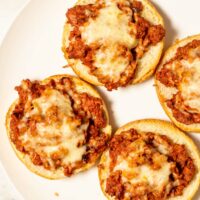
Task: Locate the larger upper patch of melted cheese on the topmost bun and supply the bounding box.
[81,1,137,48]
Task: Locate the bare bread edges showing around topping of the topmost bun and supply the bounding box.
[62,0,164,89]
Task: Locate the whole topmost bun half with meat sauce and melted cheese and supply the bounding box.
[62,0,165,90]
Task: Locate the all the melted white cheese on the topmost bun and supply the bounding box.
[81,1,138,79]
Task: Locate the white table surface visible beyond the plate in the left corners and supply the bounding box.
[0,0,28,200]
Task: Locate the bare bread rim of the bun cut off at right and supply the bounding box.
[154,35,200,132]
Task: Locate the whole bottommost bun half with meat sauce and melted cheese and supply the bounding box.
[98,119,200,200]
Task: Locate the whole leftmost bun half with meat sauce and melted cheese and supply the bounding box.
[6,74,111,179]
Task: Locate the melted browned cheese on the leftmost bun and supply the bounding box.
[20,89,88,164]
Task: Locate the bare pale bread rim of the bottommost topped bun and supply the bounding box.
[99,119,200,200]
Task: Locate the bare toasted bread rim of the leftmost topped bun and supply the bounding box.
[6,74,111,179]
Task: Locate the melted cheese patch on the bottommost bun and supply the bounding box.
[114,140,171,191]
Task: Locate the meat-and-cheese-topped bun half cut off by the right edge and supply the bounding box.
[155,35,200,132]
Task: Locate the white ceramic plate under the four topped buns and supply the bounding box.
[0,0,200,200]
